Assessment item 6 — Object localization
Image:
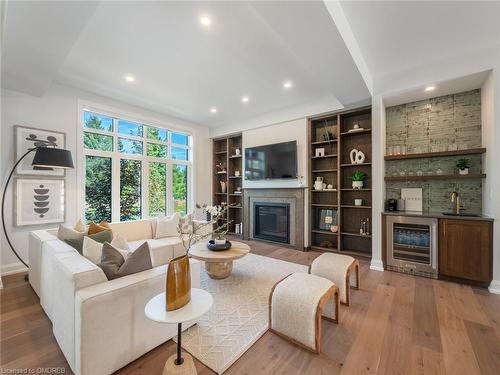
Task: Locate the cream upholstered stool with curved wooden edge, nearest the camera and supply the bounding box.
[269,272,339,353]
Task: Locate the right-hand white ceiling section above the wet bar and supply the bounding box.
[341,1,500,84]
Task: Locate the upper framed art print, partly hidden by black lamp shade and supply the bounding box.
[14,125,66,177]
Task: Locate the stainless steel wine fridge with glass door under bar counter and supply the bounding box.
[386,215,438,279]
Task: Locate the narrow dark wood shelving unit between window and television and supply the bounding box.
[212,134,244,234]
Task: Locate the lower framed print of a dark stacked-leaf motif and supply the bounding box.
[15,178,65,226]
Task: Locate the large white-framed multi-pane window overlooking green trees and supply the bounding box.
[82,111,192,222]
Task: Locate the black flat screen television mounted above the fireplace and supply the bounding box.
[245,141,297,180]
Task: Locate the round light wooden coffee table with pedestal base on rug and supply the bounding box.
[189,241,250,279]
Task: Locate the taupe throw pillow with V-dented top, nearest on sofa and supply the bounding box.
[98,242,153,280]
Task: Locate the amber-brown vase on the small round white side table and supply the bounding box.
[165,254,191,311]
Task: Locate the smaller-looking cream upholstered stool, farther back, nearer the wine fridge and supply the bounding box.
[309,253,359,306]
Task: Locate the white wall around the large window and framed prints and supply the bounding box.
[0,85,212,274]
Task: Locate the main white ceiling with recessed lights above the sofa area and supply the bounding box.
[2,1,370,127]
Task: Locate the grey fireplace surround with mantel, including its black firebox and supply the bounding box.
[243,188,305,251]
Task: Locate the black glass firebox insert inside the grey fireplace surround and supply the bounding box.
[253,202,290,244]
